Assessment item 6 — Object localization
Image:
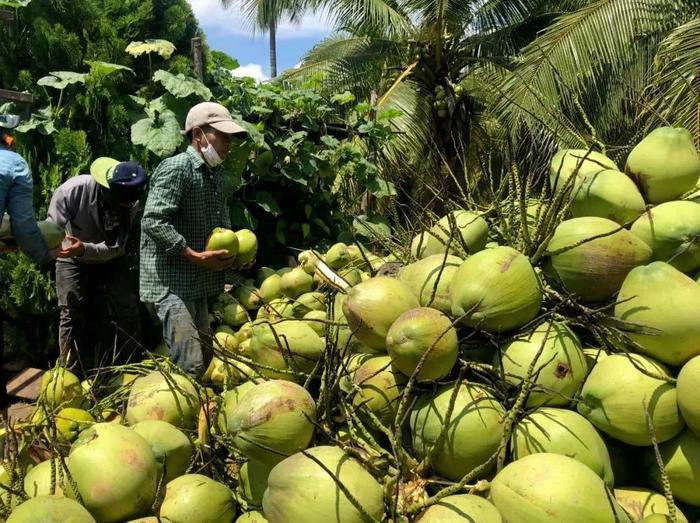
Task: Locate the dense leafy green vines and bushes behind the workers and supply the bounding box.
[0,0,395,363]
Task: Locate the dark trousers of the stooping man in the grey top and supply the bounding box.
[56,258,141,369]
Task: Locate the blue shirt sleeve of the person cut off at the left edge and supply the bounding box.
[7,155,49,264]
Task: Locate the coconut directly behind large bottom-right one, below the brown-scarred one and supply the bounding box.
[510,407,615,487]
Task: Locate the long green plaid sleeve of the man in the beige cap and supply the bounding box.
[141,163,187,256]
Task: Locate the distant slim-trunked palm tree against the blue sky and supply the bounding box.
[221,0,307,78]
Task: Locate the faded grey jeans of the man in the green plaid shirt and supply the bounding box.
[153,292,212,378]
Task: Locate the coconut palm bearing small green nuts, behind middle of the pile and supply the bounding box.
[287,0,552,201]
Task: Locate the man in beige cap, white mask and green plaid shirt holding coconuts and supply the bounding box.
[140,102,246,377]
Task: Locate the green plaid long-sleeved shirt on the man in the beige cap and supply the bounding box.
[140,147,231,303]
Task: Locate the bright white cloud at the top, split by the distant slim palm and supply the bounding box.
[189,0,333,40]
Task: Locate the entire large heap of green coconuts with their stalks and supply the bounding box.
[0,128,700,523]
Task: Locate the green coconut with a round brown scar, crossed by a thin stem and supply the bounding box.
[496,322,588,407]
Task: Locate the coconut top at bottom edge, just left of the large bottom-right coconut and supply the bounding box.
[416,494,503,523]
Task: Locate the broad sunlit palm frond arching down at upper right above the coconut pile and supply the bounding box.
[497,0,692,149]
